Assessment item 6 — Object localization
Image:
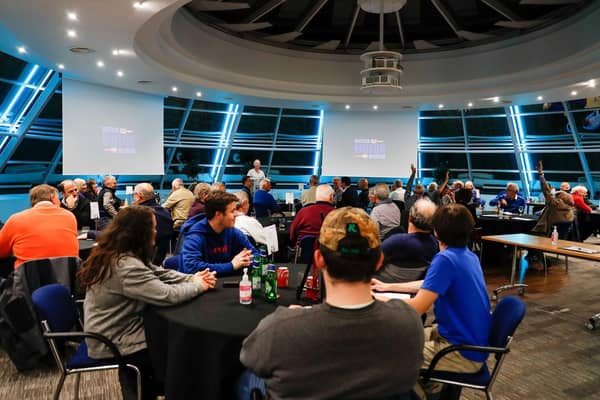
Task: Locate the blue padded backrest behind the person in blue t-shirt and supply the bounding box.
[489,296,526,347]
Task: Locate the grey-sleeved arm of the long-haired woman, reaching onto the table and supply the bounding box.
[118,257,208,306]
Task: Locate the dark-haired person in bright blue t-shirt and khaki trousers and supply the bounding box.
[371,204,491,392]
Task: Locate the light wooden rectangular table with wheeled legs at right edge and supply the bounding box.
[481,233,600,300]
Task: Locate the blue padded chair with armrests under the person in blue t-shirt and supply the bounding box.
[421,296,525,400]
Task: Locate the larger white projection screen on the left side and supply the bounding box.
[62,79,164,175]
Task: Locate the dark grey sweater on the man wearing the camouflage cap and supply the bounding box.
[240,300,423,400]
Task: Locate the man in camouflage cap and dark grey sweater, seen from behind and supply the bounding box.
[239,208,423,399]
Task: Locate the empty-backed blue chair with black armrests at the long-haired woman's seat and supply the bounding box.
[31,284,142,400]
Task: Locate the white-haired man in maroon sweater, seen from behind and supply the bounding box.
[290,185,334,246]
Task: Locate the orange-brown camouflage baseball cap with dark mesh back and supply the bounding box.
[319,207,381,257]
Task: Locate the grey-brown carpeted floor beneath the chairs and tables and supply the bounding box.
[0,259,600,400]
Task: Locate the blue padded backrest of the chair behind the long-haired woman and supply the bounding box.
[31,283,79,332]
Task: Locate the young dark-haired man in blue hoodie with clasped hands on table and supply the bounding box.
[175,191,259,276]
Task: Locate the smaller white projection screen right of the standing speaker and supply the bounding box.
[322,111,419,178]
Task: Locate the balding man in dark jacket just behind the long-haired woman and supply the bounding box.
[133,183,173,265]
